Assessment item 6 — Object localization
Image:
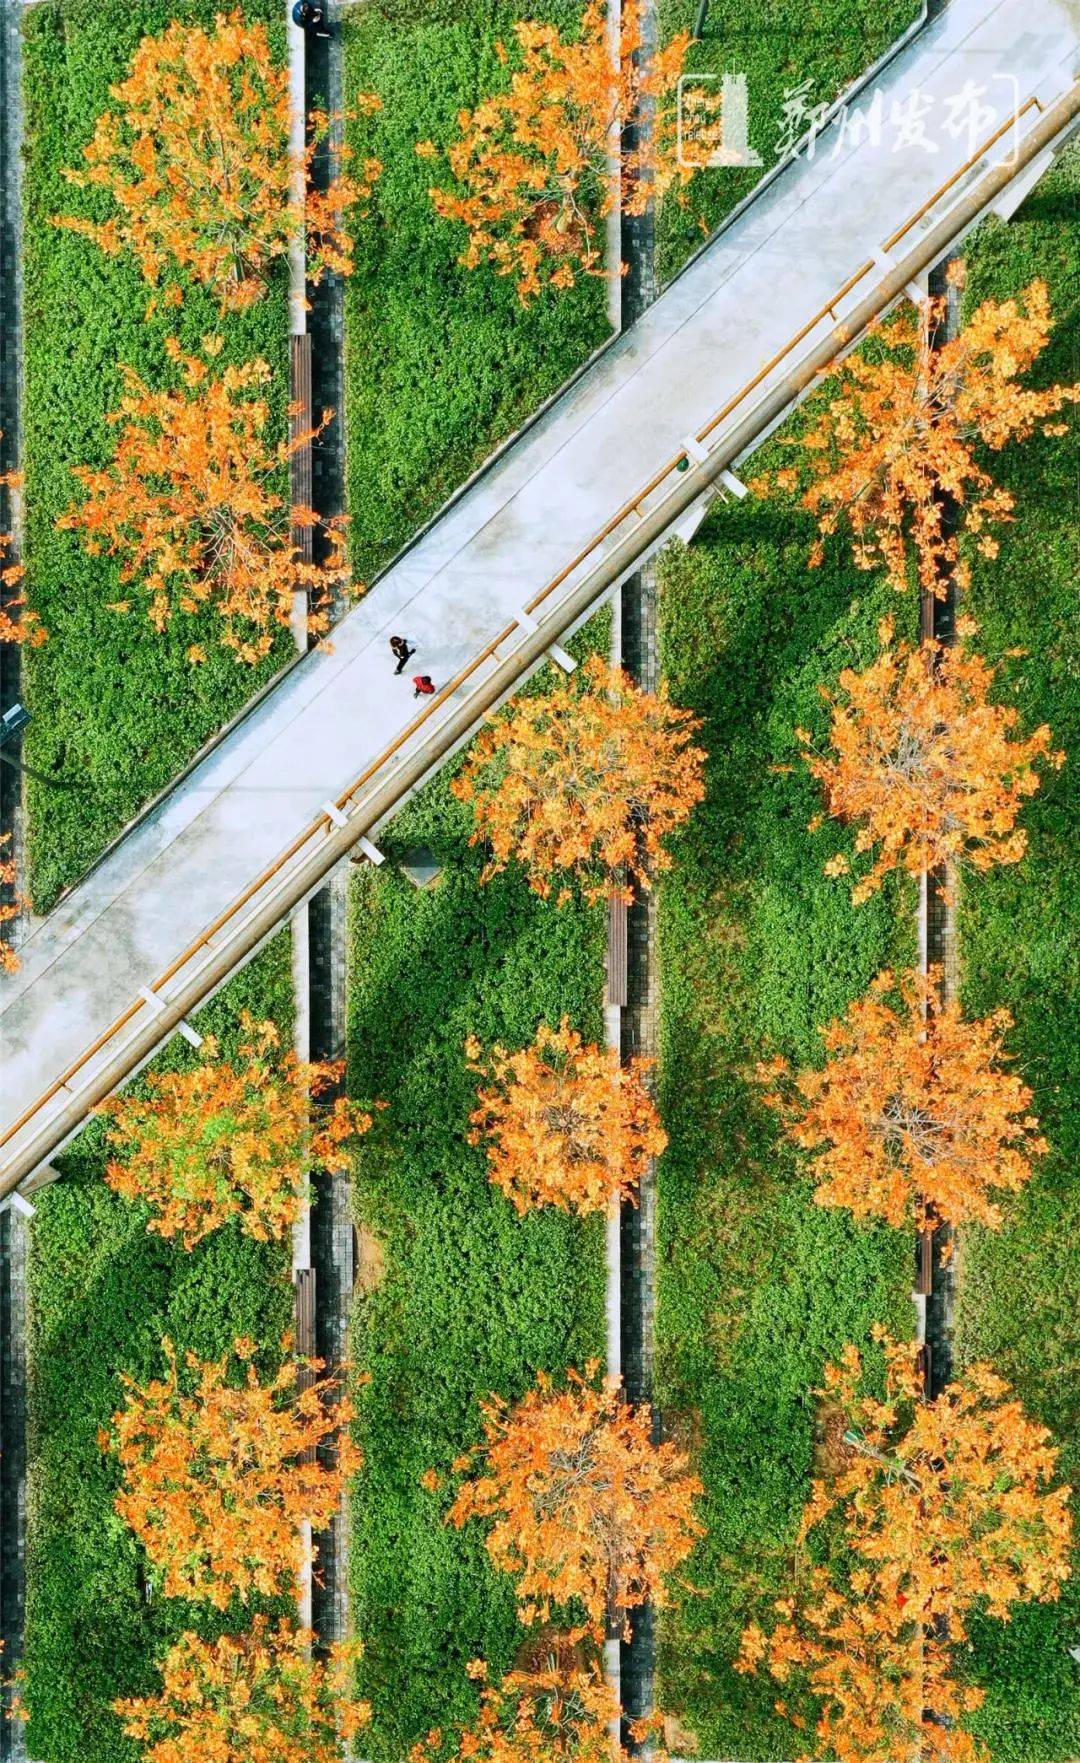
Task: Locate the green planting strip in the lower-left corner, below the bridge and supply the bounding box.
[25,934,292,1763]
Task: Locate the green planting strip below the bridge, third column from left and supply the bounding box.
[657,479,914,1758]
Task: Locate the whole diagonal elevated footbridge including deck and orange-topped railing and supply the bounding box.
[0,0,1080,1195]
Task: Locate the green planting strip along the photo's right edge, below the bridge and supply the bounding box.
[957,150,1080,1763]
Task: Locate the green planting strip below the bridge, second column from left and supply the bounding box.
[349,621,608,1763]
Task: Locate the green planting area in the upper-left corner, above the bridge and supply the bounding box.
[23,0,291,911]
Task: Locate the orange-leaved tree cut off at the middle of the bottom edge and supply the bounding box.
[409,1634,655,1763]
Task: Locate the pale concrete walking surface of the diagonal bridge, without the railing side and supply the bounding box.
[0,0,1080,1184]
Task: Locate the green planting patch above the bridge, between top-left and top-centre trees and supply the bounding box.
[344,0,608,577]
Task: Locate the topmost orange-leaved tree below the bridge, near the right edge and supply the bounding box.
[754,282,1080,594]
